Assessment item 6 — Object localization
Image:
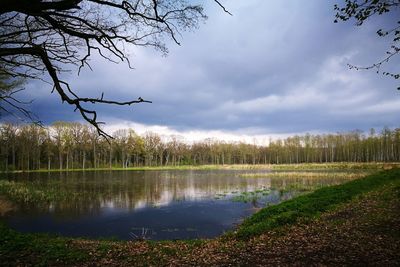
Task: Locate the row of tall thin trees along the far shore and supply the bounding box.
[0,122,400,171]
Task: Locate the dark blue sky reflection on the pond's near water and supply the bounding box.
[8,200,260,240]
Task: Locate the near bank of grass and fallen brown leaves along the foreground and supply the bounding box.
[0,169,400,266]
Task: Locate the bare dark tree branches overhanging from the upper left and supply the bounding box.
[0,0,229,137]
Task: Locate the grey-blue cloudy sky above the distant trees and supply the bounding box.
[3,0,400,142]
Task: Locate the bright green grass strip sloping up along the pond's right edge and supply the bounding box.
[233,169,400,239]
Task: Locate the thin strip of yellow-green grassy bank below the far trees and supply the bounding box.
[0,162,400,173]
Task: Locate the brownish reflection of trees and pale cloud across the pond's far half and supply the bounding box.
[11,171,350,218]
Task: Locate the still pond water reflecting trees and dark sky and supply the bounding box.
[1,170,348,240]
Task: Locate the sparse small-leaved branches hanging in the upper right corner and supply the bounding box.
[334,0,400,90]
